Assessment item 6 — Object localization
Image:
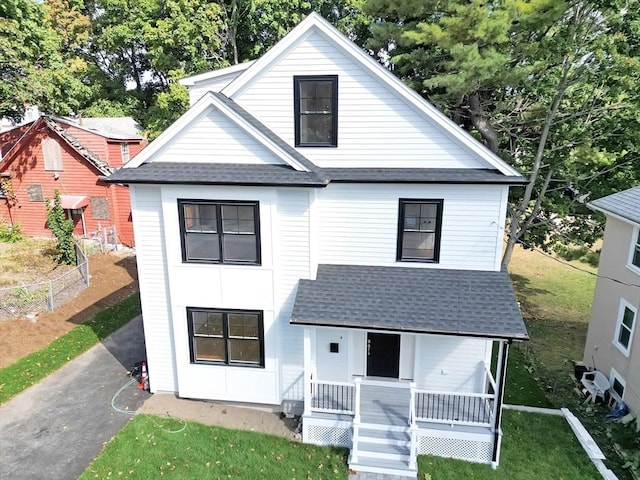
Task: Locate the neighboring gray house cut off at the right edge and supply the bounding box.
[584,186,640,414]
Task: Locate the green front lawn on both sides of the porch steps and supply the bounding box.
[80,411,599,480]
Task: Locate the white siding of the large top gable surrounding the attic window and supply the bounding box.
[232,32,487,168]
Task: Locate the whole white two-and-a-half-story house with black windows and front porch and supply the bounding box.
[110,14,527,476]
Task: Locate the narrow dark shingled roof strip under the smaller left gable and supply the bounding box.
[106,162,326,187]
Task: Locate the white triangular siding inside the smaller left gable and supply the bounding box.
[153,106,283,164]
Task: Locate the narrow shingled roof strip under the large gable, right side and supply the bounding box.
[325,168,526,185]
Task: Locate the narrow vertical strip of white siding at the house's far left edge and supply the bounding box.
[130,185,178,393]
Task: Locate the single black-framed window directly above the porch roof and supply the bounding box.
[396,199,443,262]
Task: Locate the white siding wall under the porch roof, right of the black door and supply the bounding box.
[414,335,492,393]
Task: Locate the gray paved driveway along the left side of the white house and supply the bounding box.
[0,317,149,480]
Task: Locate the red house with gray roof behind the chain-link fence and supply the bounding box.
[0,116,146,246]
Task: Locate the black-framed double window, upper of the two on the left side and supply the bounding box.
[178,200,260,265]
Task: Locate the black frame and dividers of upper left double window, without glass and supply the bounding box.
[178,199,262,265]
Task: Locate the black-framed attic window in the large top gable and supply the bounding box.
[293,75,338,147]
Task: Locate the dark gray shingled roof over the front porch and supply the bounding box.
[291,265,529,340]
